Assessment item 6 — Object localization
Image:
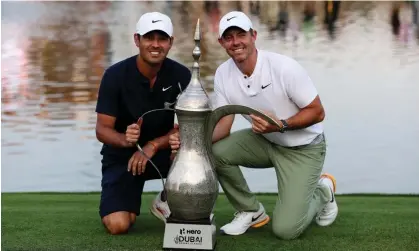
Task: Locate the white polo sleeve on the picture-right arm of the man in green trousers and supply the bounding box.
[283,60,318,108]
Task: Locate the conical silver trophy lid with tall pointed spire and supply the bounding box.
[175,19,211,112]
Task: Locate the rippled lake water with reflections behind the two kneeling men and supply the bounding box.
[1,1,419,193]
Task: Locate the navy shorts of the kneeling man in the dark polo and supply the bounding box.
[99,150,171,218]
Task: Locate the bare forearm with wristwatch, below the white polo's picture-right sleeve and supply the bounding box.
[285,108,324,130]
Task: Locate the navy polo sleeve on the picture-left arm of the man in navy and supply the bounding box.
[96,70,119,117]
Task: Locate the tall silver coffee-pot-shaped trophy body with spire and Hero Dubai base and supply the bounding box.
[163,19,219,250]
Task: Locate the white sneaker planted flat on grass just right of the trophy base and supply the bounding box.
[220,203,270,235]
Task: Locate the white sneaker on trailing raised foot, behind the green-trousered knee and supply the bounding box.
[316,173,338,227]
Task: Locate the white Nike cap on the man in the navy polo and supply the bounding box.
[136,12,173,37]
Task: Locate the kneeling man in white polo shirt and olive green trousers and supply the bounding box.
[169,11,338,239]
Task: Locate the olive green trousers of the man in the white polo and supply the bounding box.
[212,129,331,239]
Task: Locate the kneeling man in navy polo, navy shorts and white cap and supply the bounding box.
[96,12,191,234]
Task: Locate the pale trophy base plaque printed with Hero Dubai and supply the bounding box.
[163,214,216,250]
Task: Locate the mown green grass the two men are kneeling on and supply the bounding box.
[1,193,419,251]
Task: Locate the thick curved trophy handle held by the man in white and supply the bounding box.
[205,105,281,167]
